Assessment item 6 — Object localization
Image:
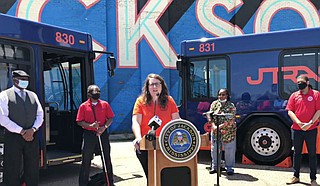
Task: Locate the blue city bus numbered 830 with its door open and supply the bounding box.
[0,14,115,178]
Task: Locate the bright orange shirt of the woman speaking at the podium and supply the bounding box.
[132,96,179,137]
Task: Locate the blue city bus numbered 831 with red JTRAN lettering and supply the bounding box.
[177,28,320,165]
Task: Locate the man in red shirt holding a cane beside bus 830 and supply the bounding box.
[76,85,114,186]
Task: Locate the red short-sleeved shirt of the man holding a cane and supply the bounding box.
[76,99,114,131]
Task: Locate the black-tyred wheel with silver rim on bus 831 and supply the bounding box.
[243,117,291,165]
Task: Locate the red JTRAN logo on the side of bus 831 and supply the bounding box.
[247,66,320,85]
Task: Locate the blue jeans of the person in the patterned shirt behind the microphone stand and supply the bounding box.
[211,136,236,171]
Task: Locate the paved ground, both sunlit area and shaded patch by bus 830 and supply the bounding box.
[40,141,319,186]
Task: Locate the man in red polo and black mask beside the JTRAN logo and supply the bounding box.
[286,75,320,186]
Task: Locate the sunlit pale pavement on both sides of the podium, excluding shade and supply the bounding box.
[89,141,319,186]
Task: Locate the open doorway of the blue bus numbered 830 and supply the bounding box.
[43,50,89,166]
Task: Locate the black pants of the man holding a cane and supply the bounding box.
[79,130,113,186]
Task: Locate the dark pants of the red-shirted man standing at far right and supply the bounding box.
[291,129,318,180]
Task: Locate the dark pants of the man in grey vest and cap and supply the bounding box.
[3,130,40,186]
